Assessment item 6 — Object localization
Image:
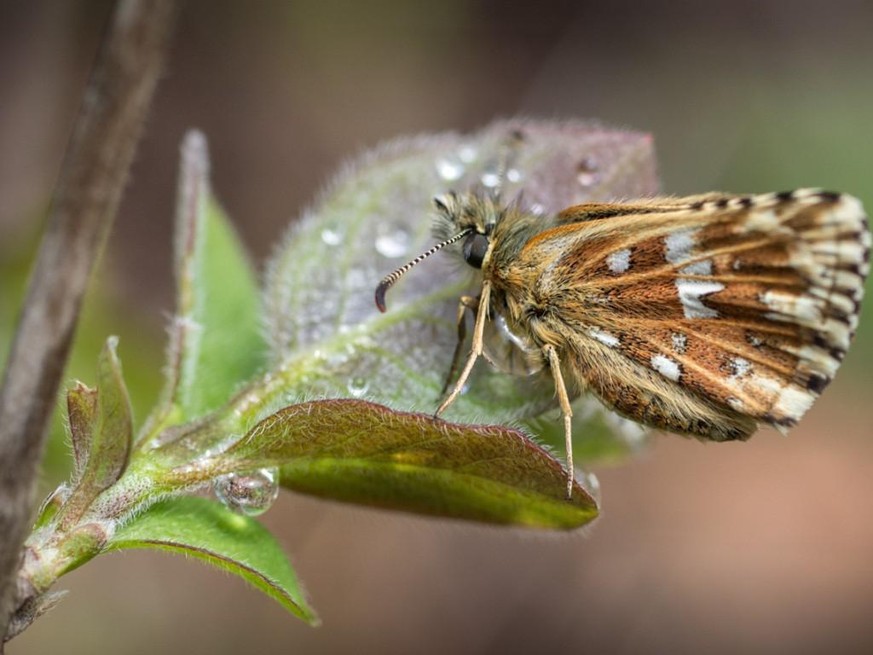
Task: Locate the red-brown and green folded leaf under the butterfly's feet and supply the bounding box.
[198,400,597,529]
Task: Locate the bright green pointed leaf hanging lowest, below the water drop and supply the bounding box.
[107,497,319,625]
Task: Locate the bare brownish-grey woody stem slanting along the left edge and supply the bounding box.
[0,0,176,653]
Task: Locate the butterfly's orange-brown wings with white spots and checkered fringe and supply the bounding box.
[520,190,870,436]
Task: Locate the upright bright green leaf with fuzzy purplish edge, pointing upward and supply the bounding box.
[143,132,266,436]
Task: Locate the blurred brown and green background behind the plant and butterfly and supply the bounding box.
[0,0,873,655]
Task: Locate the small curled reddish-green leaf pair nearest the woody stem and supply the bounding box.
[60,337,133,526]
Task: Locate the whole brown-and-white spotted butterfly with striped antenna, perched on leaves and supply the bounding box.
[376,189,871,496]
